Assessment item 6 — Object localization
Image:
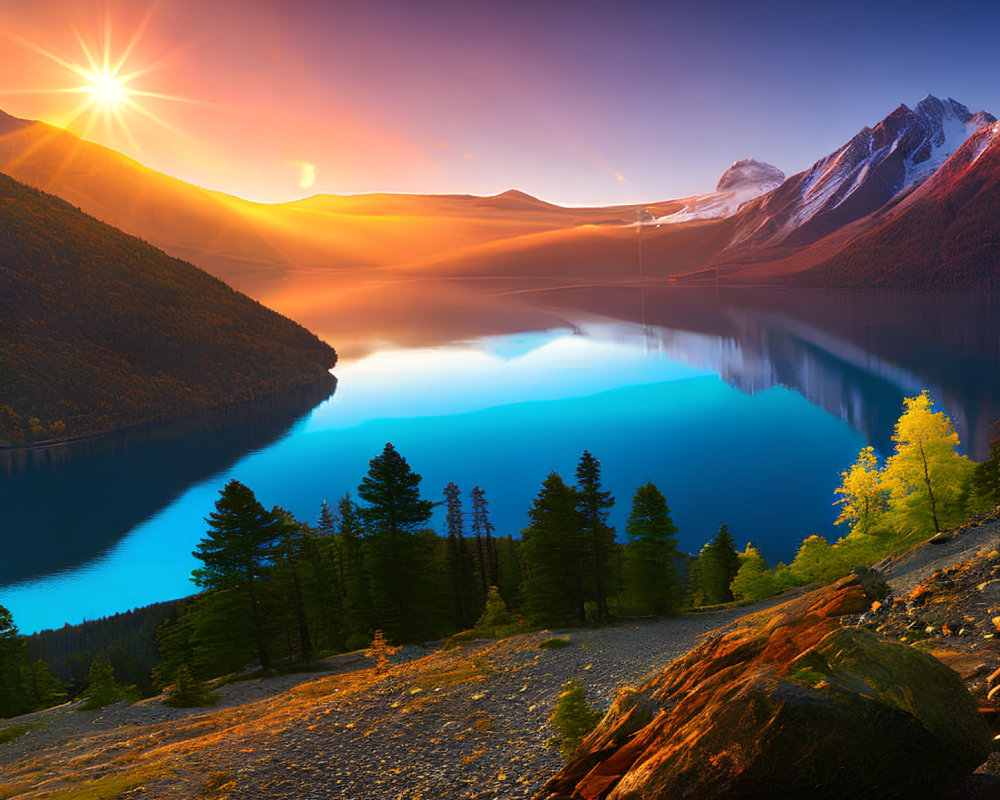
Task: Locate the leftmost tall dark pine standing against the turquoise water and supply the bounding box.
[192,480,281,669]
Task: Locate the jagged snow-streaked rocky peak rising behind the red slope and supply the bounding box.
[730,95,997,249]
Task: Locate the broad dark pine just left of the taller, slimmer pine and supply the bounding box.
[521,472,589,625]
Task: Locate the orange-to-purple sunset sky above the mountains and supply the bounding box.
[0,0,1000,205]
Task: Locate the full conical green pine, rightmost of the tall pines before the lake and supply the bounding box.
[624,483,680,614]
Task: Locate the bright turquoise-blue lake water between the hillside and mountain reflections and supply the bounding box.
[0,331,865,632]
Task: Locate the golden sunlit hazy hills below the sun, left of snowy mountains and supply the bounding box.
[0,112,679,304]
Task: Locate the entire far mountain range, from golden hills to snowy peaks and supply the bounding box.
[0,95,1000,310]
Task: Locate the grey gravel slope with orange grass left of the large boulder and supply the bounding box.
[0,598,796,800]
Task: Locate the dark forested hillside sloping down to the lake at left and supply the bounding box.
[0,174,337,446]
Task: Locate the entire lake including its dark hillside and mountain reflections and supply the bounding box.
[0,285,1000,632]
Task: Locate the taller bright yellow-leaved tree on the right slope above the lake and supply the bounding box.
[882,390,975,535]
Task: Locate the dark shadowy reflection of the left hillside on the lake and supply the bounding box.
[0,379,335,586]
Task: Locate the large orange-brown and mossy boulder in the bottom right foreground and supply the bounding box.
[536,576,990,800]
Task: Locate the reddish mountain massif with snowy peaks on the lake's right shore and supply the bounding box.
[408,95,1000,289]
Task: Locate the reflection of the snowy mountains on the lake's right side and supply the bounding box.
[541,287,1000,459]
